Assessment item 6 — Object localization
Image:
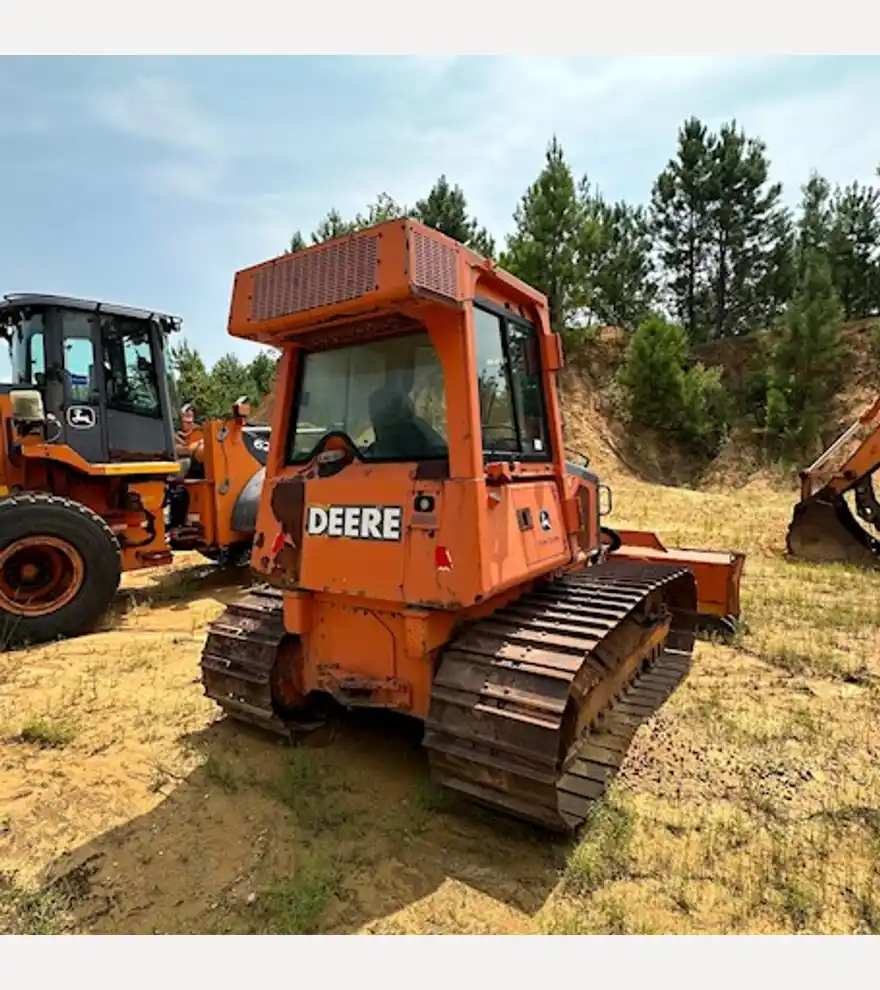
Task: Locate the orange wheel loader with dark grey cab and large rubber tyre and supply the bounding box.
[0,294,268,645]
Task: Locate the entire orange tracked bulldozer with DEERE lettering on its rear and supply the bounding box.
[201,220,744,832]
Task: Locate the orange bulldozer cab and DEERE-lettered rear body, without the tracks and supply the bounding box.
[230,222,576,608]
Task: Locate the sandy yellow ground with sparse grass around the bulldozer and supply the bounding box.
[0,479,880,933]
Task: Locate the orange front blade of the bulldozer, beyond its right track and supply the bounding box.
[608,529,746,633]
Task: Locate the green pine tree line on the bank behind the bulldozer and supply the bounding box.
[170,117,880,456]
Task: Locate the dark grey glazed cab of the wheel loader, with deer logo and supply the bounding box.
[0,295,179,464]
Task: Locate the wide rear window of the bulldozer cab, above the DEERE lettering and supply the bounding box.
[289,333,447,464]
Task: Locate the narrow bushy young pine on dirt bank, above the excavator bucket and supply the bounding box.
[764,251,843,456]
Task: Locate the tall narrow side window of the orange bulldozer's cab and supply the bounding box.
[474,306,550,460]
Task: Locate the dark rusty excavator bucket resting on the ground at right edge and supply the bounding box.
[786,493,880,569]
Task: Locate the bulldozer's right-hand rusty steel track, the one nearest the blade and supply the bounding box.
[424,562,694,832]
